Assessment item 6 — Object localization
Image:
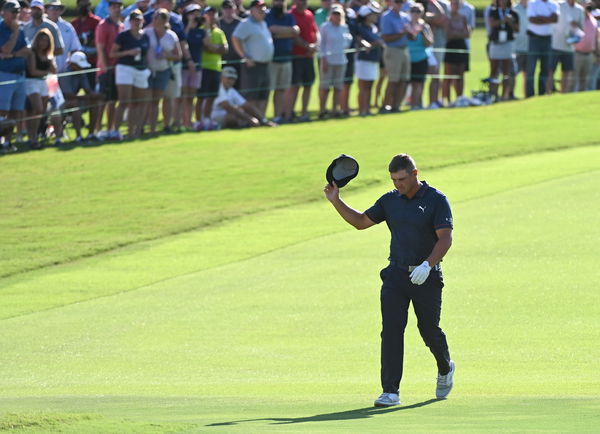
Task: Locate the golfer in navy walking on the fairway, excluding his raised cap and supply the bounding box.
[324,154,455,407]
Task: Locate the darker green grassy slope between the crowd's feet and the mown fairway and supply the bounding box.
[0,93,598,276]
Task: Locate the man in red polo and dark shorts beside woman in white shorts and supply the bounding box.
[95,0,124,140]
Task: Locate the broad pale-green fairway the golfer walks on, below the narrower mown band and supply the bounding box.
[0,162,600,432]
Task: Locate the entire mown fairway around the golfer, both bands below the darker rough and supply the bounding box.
[0,140,600,433]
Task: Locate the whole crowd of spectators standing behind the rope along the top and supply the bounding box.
[0,0,600,152]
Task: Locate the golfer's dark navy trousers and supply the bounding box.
[380,265,450,393]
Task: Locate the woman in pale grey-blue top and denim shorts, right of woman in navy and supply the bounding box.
[144,9,181,134]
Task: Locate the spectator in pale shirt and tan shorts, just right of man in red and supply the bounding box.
[319,4,352,119]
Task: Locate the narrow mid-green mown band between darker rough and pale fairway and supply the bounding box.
[0,147,600,319]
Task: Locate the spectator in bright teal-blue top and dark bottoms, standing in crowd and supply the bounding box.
[408,3,433,110]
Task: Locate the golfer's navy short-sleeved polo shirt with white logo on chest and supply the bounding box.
[365,181,452,266]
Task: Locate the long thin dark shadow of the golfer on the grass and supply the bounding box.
[206,399,440,426]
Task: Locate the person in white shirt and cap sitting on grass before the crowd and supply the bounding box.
[211,66,275,128]
